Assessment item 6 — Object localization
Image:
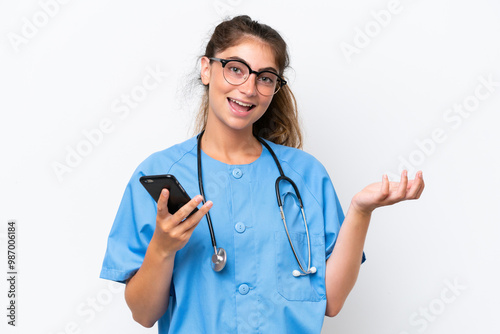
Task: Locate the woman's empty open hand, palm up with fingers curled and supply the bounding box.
[351,170,424,215]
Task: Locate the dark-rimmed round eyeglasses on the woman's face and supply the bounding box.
[209,57,286,96]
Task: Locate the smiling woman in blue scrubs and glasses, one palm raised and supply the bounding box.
[101,16,424,333]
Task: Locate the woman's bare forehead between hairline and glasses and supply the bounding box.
[217,38,278,70]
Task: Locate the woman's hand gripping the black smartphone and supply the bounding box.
[151,189,213,257]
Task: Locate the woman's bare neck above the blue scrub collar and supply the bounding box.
[201,124,262,165]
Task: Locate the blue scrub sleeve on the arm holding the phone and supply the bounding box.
[100,170,156,283]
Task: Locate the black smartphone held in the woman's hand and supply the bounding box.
[139,174,198,217]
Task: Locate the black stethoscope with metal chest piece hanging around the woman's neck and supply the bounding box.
[197,131,316,277]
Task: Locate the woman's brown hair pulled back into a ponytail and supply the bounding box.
[195,15,302,148]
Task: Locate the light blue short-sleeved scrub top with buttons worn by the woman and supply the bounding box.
[100,137,364,333]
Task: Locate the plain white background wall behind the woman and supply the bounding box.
[0,0,500,334]
